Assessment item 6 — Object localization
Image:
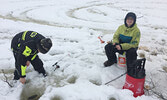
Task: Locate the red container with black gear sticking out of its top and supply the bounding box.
[123,58,146,97]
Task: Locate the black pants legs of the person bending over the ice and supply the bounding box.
[13,52,46,80]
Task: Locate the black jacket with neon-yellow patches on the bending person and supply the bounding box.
[11,31,45,77]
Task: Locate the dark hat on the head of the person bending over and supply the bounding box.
[37,38,52,54]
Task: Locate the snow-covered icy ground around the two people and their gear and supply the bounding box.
[0,0,167,100]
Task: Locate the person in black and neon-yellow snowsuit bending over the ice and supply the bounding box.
[11,31,52,84]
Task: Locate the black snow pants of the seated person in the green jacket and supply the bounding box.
[105,43,137,68]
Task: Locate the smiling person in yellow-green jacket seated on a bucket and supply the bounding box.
[104,12,140,67]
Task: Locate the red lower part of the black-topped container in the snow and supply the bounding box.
[123,74,145,97]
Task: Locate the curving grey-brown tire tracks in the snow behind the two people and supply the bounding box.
[0,4,115,33]
